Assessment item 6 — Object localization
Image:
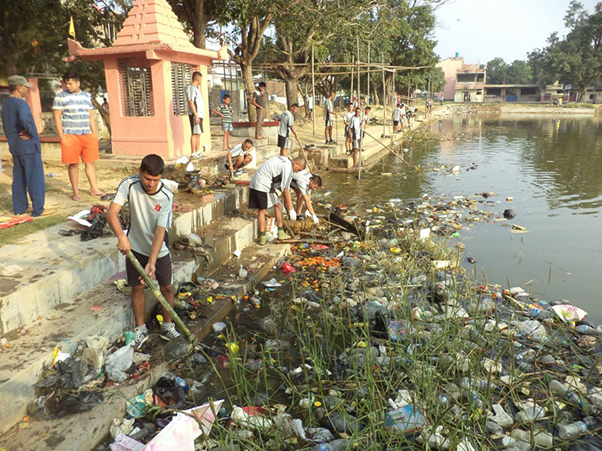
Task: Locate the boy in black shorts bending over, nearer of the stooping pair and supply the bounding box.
[249,155,305,245]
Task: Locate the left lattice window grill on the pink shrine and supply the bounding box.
[118,59,155,117]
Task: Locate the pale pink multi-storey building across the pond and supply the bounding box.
[435,53,487,102]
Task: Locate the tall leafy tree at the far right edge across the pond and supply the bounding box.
[529,0,602,102]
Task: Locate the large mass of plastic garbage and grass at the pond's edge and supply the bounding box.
[163,203,602,450]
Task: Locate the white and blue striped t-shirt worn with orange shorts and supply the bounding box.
[52,91,94,135]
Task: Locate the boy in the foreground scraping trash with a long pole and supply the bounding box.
[107,155,180,349]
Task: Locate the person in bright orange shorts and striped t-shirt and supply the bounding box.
[52,71,106,200]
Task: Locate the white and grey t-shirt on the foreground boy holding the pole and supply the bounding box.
[113,175,174,258]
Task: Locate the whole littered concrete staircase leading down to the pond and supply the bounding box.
[0,188,288,450]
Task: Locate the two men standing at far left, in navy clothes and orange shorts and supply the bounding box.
[2,71,106,218]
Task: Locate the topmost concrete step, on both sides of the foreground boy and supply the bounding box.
[0,190,246,335]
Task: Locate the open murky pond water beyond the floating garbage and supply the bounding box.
[317,114,602,324]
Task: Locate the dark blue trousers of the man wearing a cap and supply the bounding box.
[13,152,46,216]
